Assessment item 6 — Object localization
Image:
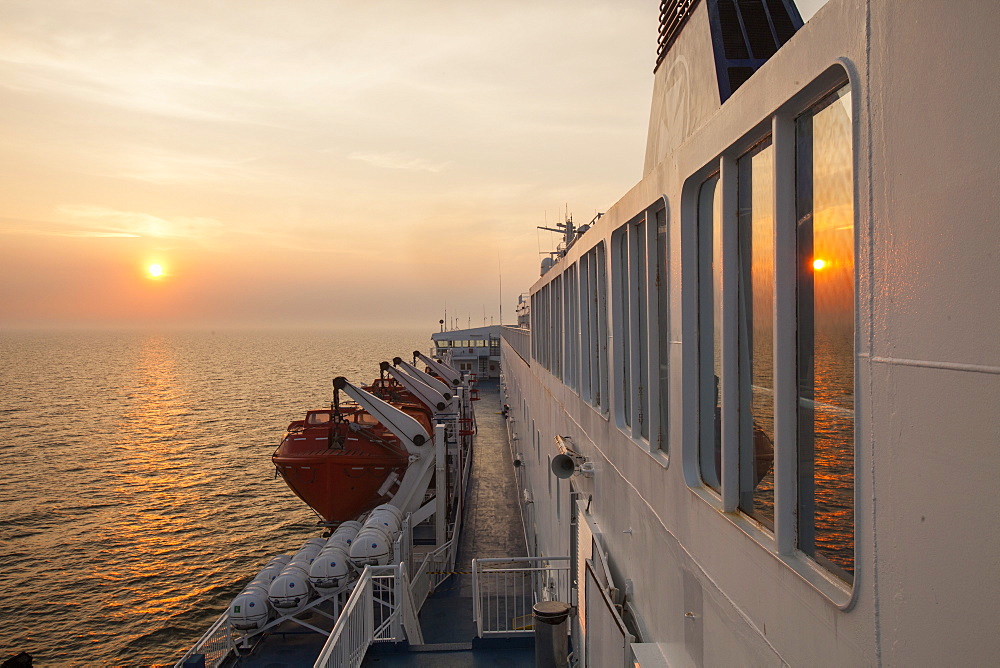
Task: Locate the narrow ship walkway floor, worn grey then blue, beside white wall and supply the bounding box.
[224,380,534,668]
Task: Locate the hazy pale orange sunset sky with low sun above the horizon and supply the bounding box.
[0,0,824,329]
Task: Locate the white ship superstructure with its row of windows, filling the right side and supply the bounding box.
[501,0,1000,667]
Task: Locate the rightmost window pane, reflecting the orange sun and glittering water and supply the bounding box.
[796,87,855,580]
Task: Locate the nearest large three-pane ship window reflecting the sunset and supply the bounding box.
[696,75,856,582]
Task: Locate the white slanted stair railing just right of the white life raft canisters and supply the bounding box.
[313,564,423,668]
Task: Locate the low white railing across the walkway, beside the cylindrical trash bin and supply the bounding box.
[472,557,570,638]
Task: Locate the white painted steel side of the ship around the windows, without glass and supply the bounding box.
[501,0,1000,666]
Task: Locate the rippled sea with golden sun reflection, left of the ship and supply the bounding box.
[0,330,430,666]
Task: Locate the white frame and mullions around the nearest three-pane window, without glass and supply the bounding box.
[680,64,865,610]
